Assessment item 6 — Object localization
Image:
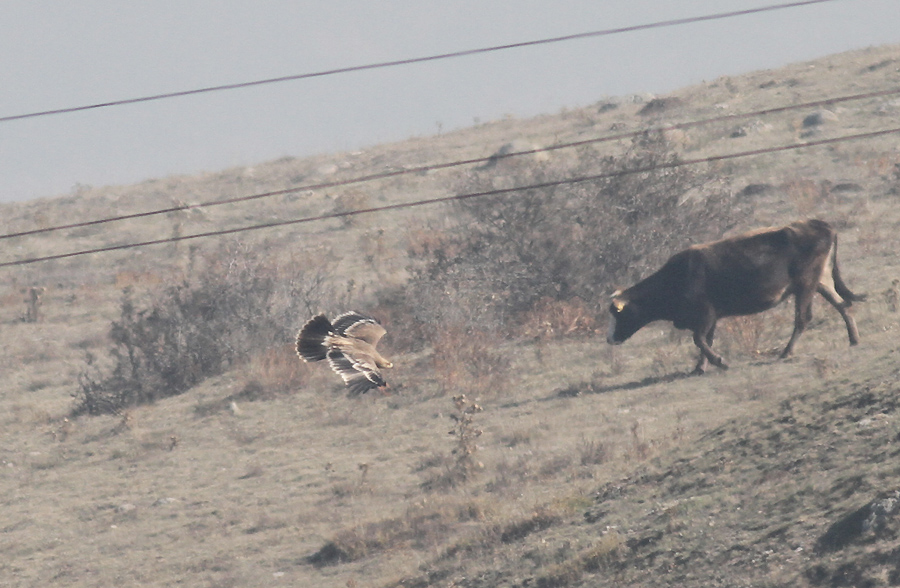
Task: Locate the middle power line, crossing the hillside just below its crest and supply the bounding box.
[0,88,900,242]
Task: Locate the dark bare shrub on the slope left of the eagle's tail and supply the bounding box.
[72,243,337,415]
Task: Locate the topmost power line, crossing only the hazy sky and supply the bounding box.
[0,0,835,123]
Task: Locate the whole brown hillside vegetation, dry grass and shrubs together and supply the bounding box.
[0,42,900,588]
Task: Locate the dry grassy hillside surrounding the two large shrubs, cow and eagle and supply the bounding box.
[0,46,900,587]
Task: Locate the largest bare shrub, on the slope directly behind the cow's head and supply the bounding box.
[398,133,749,334]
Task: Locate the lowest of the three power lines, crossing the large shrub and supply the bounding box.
[0,127,900,268]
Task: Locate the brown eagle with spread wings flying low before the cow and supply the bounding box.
[297,311,393,396]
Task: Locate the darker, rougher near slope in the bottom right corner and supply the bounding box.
[397,336,900,587]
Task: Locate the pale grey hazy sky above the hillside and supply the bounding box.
[0,0,900,201]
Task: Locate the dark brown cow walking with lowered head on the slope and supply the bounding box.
[607,220,865,374]
